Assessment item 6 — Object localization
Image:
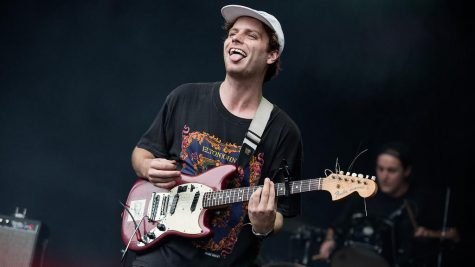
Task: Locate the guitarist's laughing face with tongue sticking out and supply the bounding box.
[223,17,278,78]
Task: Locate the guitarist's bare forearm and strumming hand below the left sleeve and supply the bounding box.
[132,147,180,188]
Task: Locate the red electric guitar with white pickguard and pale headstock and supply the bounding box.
[122,165,377,251]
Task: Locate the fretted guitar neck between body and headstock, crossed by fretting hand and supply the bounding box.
[203,178,324,208]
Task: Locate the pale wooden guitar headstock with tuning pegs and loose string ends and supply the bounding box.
[322,171,378,200]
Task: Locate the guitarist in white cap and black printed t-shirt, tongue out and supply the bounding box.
[128,5,303,266]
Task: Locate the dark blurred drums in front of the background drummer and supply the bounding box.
[263,218,393,267]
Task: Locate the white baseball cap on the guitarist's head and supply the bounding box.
[221,5,285,55]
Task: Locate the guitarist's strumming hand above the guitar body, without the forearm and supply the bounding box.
[145,158,181,189]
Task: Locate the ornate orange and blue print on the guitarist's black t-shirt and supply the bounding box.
[180,125,264,258]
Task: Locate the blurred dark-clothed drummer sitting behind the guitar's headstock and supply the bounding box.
[312,142,459,266]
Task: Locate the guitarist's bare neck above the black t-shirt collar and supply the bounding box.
[219,76,262,119]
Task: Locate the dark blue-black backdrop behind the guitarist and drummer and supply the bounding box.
[0,0,474,266]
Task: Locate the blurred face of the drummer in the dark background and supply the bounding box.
[376,154,410,197]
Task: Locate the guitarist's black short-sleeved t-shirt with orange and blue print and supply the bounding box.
[136,82,303,266]
